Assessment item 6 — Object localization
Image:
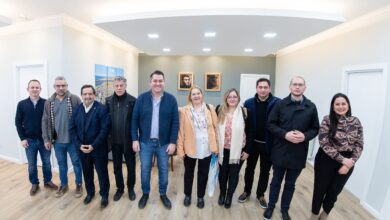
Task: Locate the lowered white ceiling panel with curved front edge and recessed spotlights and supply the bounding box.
[94,9,344,56]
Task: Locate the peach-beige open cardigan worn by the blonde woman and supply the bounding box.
[177,105,218,157]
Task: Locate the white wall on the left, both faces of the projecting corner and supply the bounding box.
[0,16,138,162]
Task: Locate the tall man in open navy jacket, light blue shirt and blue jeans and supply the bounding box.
[131,70,179,209]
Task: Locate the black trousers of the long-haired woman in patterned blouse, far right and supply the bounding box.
[311,148,354,214]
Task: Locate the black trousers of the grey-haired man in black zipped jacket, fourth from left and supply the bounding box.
[111,144,135,190]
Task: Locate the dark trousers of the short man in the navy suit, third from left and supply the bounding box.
[79,152,110,199]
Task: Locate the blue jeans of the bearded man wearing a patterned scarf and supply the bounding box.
[54,143,82,186]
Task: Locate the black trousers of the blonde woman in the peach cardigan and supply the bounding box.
[184,155,211,198]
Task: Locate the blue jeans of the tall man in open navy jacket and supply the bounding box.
[139,139,169,195]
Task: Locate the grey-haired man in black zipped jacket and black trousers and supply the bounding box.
[106,76,136,201]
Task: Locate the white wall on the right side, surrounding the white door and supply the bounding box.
[275,8,390,217]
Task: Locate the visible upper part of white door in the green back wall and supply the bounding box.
[240,73,270,105]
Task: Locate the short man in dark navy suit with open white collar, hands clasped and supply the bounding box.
[69,85,110,208]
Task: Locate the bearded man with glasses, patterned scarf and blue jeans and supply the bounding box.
[42,76,83,198]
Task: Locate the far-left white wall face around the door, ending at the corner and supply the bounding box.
[0,27,62,162]
